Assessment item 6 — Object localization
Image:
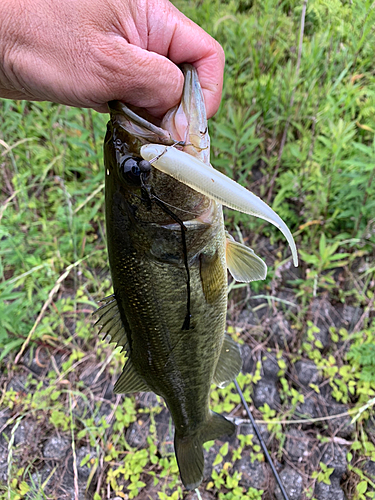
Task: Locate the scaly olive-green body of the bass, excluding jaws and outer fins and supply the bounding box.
[105,122,227,436]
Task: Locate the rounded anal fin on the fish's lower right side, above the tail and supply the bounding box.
[213,335,242,388]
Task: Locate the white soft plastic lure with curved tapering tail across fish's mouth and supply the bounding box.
[141,144,298,267]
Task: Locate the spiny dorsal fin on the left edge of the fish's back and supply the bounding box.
[93,294,128,351]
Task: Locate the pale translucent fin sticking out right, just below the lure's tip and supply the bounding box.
[226,234,267,283]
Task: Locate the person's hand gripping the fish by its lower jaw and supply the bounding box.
[0,0,224,117]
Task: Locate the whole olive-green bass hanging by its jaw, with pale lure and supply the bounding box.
[96,65,295,490]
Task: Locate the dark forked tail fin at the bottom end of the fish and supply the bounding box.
[174,412,235,490]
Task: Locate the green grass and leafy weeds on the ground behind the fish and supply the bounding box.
[0,0,375,500]
